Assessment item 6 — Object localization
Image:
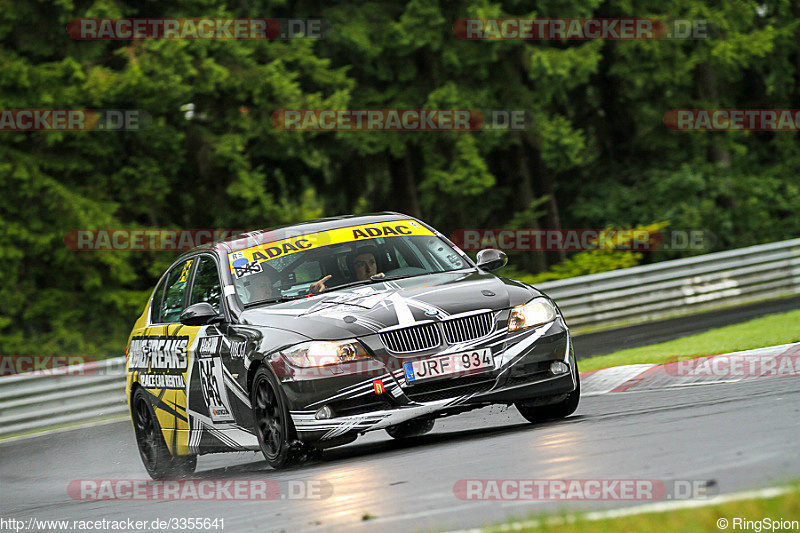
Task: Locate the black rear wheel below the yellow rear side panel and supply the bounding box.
[132,388,197,479]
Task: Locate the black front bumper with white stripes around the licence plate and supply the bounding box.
[274,316,578,444]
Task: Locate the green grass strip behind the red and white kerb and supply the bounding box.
[578,310,800,372]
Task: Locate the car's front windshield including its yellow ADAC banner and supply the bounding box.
[228,220,472,305]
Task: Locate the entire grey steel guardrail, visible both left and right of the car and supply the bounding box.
[0,239,800,438]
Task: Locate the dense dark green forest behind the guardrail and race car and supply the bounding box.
[0,0,800,355]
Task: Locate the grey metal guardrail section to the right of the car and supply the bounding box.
[537,239,800,330]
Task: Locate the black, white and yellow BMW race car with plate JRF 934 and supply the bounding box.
[126,212,580,479]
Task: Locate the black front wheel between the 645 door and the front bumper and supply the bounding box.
[250,366,299,470]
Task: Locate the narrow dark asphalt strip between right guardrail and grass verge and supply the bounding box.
[573,296,800,359]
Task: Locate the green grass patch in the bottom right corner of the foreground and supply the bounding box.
[485,490,800,533]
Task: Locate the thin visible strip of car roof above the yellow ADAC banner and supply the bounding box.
[184,211,417,255]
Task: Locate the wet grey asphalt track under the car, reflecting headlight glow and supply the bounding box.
[0,378,800,532]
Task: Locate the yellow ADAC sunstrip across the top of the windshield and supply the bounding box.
[228,220,435,278]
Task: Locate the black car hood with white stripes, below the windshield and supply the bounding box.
[240,270,541,340]
